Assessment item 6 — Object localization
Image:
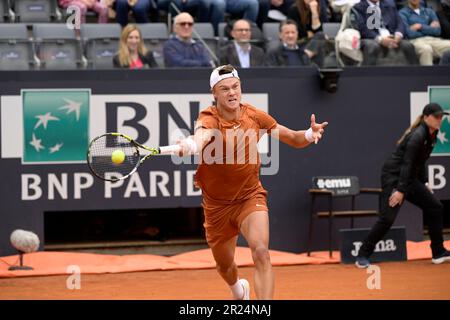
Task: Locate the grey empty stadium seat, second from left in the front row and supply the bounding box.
[33,23,84,69]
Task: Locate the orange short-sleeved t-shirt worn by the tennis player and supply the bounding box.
[195,103,277,204]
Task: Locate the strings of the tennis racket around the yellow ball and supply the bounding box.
[88,135,140,181]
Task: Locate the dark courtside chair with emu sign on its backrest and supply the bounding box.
[308,176,381,258]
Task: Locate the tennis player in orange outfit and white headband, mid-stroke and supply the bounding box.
[179,65,328,300]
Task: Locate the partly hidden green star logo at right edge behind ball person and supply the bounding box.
[428,86,450,156]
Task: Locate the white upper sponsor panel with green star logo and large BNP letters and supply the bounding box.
[0,89,268,165]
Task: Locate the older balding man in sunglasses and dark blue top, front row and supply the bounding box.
[163,12,214,67]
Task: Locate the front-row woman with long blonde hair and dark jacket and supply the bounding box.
[113,24,158,69]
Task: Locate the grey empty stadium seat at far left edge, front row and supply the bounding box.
[0,23,35,70]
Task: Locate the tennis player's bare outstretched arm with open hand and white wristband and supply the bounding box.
[271,114,328,148]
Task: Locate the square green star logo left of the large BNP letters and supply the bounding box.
[22,89,90,163]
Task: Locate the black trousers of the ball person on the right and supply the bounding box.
[359,174,445,258]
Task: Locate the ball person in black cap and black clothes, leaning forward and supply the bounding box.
[356,103,450,268]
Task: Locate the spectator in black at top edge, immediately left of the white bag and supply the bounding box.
[289,0,334,67]
